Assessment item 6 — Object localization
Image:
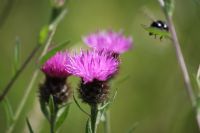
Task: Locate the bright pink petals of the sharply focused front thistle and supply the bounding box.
[66,51,119,83]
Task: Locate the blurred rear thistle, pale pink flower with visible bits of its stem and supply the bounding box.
[83,30,133,133]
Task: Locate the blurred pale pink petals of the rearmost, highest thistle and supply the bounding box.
[83,30,132,54]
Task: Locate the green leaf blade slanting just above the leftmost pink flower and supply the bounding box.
[39,41,69,65]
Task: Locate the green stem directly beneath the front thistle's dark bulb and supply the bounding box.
[91,104,98,133]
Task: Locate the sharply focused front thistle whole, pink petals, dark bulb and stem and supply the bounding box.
[66,50,119,133]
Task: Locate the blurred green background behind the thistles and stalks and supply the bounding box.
[0,0,200,133]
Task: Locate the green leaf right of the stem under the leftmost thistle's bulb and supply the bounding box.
[55,104,70,130]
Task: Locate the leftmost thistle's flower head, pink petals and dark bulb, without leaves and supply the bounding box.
[39,52,71,104]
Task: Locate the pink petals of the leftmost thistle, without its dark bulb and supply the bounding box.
[41,52,69,78]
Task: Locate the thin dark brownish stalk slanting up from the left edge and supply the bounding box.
[0,44,41,102]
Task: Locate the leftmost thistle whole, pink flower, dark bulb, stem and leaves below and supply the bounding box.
[39,52,71,133]
